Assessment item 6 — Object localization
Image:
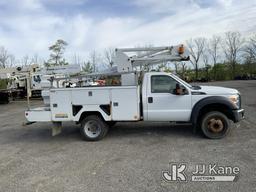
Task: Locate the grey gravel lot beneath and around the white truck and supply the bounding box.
[0,81,256,192]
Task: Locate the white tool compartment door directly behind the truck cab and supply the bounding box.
[111,86,140,121]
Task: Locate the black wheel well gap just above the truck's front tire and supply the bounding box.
[197,103,234,122]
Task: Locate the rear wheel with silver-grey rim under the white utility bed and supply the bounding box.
[80,115,109,141]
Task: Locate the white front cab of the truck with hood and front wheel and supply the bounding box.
[142,72,244,138]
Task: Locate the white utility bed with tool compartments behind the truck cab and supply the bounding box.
[27,86,140,121]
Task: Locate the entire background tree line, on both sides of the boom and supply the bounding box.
[0,31,256,81]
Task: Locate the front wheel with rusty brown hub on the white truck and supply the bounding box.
[201,111,231,139]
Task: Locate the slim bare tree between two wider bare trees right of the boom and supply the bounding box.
[208,35,221,79]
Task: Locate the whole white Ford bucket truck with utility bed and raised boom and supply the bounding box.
[25,47,244,141]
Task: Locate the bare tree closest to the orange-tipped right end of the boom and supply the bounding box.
[187,37,206,79]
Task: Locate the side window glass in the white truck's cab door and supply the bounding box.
[151,75,178,93]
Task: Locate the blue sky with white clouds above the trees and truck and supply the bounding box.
[0,0,256,62]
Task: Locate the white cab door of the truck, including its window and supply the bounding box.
[144,75,191,121]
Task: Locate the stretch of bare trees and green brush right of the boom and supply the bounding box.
[186,32,256,80]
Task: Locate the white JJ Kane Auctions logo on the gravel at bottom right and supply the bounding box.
[162,163,240,182]
